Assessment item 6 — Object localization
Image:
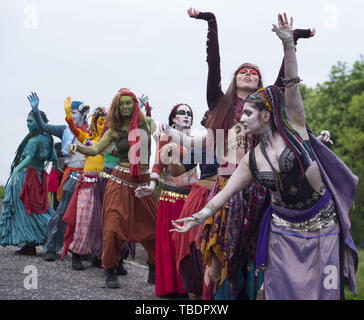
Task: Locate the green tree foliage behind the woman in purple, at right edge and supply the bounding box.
[300,56,364,246]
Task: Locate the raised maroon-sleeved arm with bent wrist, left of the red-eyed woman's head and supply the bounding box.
[187,8,224,110]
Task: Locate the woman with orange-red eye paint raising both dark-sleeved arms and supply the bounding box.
[156,8,314,299]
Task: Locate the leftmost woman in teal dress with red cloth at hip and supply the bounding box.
[0,93,58,255]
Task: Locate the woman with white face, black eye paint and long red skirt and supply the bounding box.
[135,103,198,296]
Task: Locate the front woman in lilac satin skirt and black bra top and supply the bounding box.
[172,14,358,300]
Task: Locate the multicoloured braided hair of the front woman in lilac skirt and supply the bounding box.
[246,86,312,191]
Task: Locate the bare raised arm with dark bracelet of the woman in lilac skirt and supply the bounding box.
[273,13,306,128]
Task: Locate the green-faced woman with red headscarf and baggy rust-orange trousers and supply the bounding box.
[69,89,158,288]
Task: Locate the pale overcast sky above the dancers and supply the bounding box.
[0,0,364,185]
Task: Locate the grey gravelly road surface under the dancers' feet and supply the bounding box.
[0,244,186,300]
